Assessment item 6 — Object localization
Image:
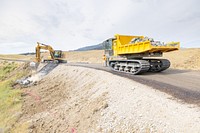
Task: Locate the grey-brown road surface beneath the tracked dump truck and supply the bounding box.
[67,63,200,106]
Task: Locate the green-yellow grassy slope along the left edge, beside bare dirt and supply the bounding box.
[0,61,28,132]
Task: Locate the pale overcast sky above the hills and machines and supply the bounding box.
[0,0,200,53]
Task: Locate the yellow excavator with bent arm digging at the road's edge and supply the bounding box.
[30,42,67,69]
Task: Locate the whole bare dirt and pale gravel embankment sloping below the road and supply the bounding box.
[14,65,200,133]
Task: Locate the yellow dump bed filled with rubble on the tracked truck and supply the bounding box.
[113,34,180,55]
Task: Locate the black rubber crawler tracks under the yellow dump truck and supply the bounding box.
[109,59,170,75]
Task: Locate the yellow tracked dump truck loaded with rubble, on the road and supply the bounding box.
[103,34,180,74]
